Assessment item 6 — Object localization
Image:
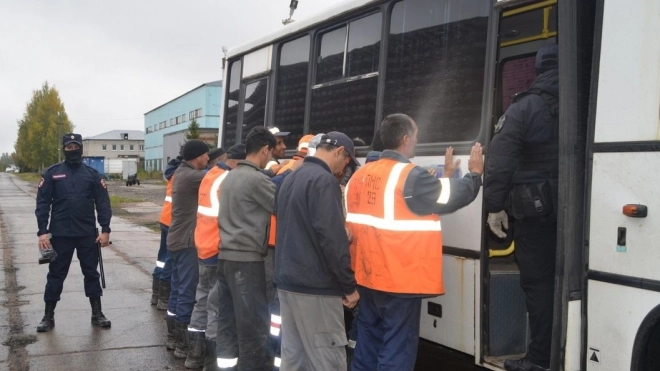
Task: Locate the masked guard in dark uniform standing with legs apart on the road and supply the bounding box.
[35,134,112,332]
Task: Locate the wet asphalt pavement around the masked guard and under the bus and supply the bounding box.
[0,173,481,371]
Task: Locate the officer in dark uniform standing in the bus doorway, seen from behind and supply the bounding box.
[484,44,559,371]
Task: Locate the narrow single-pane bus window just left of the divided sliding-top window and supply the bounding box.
[274,36,309,148]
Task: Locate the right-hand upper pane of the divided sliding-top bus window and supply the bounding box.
[346,13,383,77]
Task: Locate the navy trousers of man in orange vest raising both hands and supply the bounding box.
[351,286,422,371]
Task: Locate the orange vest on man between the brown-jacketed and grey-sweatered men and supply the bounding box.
[195,166,229,259]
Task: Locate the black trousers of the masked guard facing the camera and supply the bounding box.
[44,236,103,301]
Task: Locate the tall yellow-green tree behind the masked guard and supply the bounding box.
[14,82,73,170]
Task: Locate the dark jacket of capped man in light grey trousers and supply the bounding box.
[275,156,356,296]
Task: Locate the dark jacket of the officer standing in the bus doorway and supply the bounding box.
[484,69,559,213]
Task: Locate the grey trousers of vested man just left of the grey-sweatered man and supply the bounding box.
[188,261,220,339]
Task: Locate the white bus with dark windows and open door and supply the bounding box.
[219,0,660,371]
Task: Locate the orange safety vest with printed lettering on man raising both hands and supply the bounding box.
[345,159,449,295]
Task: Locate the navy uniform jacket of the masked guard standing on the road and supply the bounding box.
[35,162,112,237]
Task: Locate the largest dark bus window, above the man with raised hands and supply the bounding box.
[383,0,492,143]
